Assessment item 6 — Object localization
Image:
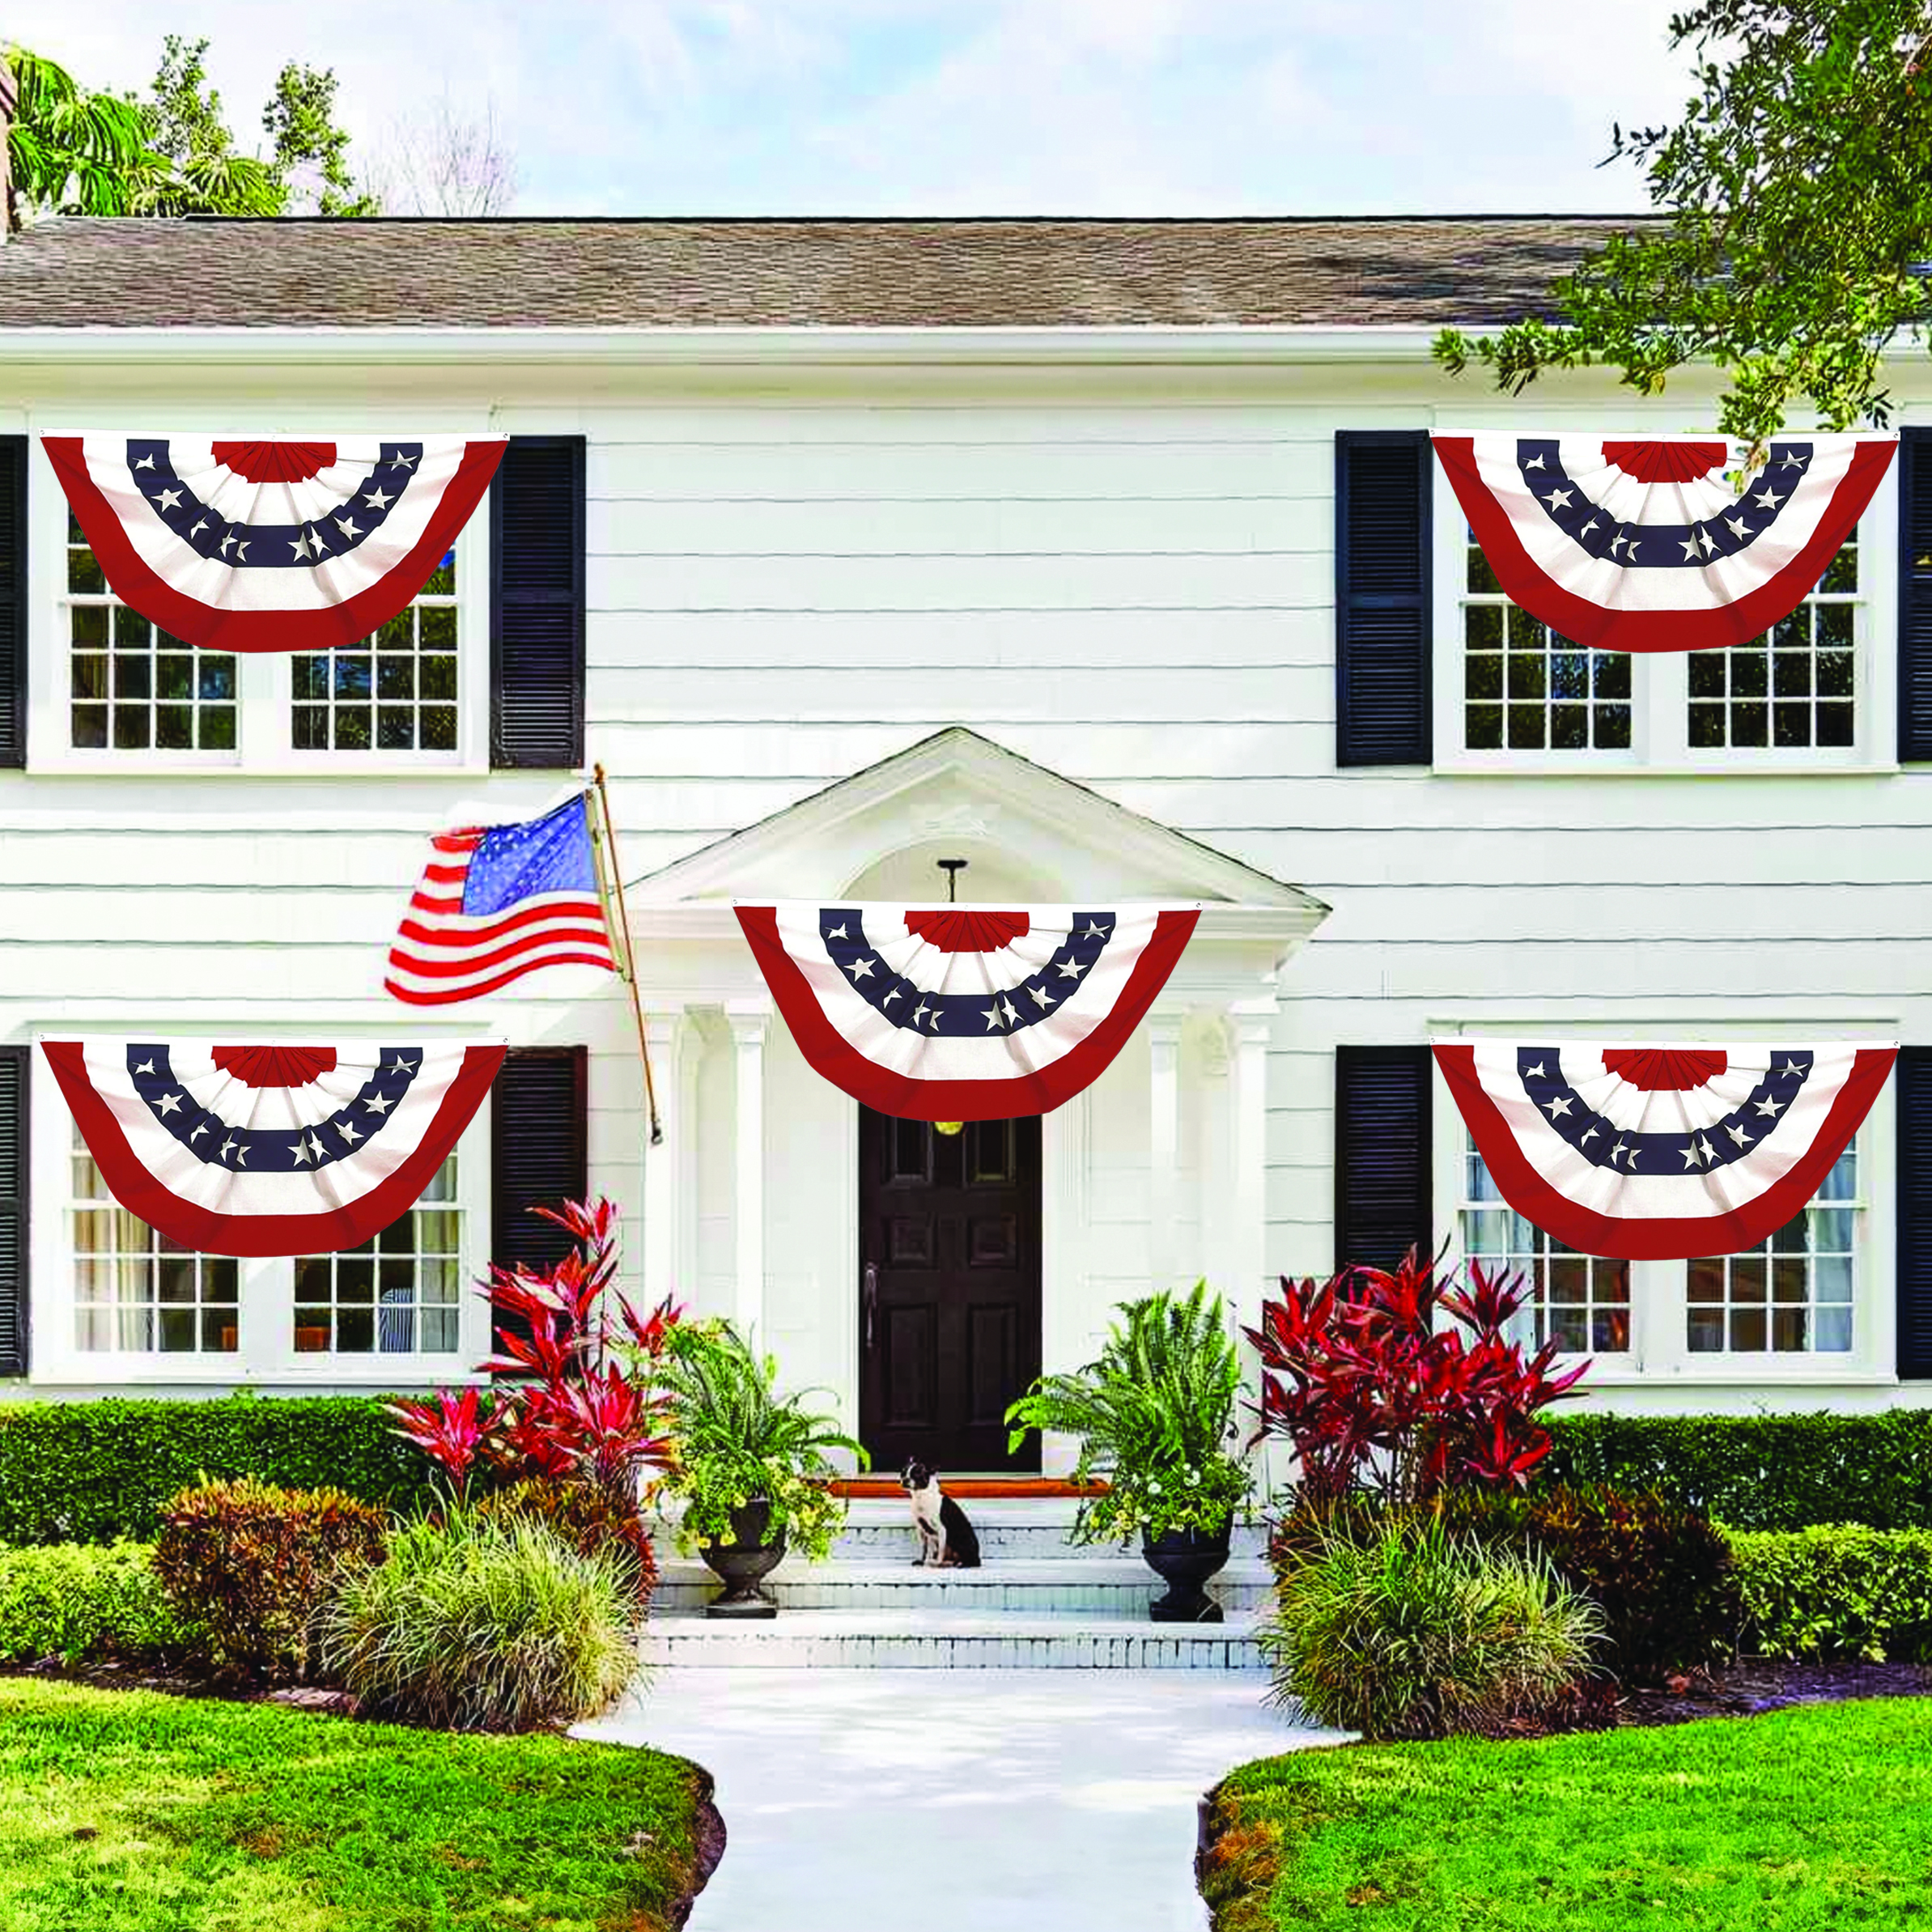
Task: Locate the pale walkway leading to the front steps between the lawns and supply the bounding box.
[578,1669,1337,1932]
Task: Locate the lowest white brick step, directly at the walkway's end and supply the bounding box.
[638,1609,1263,1671]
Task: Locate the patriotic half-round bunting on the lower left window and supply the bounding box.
[43,1039,504,1256]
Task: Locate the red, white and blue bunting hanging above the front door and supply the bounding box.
[738,900,1200,1120]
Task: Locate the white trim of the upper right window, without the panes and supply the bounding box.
[1429,452,1899,779]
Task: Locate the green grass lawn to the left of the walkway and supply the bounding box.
[0,1679,711,1932]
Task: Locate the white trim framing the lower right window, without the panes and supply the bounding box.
[1428,1013,1899,1395]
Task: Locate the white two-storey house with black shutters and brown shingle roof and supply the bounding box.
[0,219,1932,1468]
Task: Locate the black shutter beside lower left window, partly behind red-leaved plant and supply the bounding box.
[489,1047,589,1269]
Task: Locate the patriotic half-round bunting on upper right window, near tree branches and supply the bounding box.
[1433,433,1899,651]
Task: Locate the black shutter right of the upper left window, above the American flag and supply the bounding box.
[489,436,585,771]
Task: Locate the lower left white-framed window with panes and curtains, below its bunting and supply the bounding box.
[29,1053,490,1387]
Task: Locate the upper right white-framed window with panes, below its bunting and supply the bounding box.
[1432,456,1897,775]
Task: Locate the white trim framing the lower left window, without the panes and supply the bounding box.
[27,1020,495,1389]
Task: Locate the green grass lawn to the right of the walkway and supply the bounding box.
[1205,1698,1932,1932]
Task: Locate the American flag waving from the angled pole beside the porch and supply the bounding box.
[383,792,616,1007]
